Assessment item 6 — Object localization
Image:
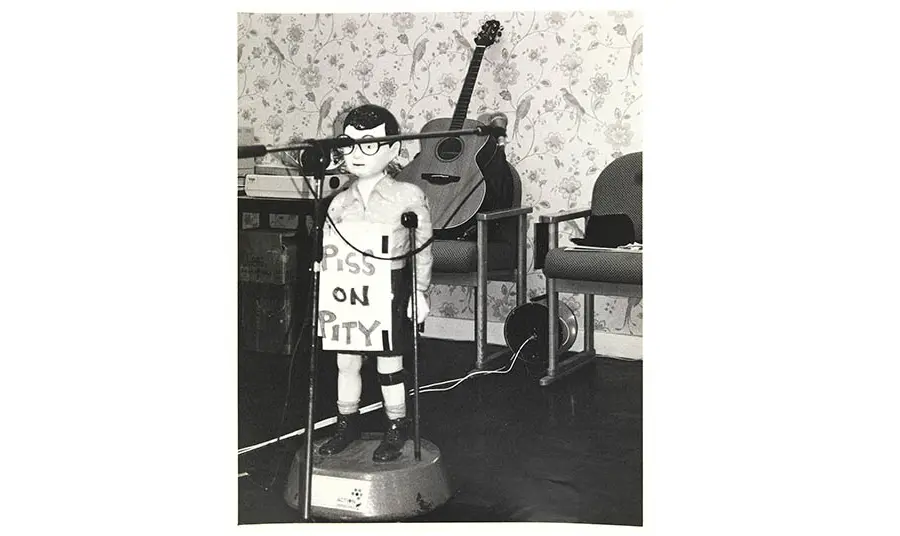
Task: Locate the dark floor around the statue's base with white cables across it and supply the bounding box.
[238,339,643,526]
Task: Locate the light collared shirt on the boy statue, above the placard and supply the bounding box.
[325,176,432,292]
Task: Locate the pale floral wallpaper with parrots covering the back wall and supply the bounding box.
[237,11,644,335]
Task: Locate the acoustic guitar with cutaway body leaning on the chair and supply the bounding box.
[397,20,502,232]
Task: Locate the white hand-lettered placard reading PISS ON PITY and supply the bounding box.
[318,222,393,352]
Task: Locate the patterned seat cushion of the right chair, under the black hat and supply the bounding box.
[544,248,644,285]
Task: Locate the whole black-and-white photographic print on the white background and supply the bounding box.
[237,10,644,527]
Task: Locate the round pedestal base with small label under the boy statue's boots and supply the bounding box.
[284,434,451,521]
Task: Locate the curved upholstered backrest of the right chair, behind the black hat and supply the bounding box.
[591,152,644,242]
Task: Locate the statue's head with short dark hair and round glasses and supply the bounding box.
[341,104,400,179]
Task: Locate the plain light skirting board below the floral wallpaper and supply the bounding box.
[422,317,644,359]
